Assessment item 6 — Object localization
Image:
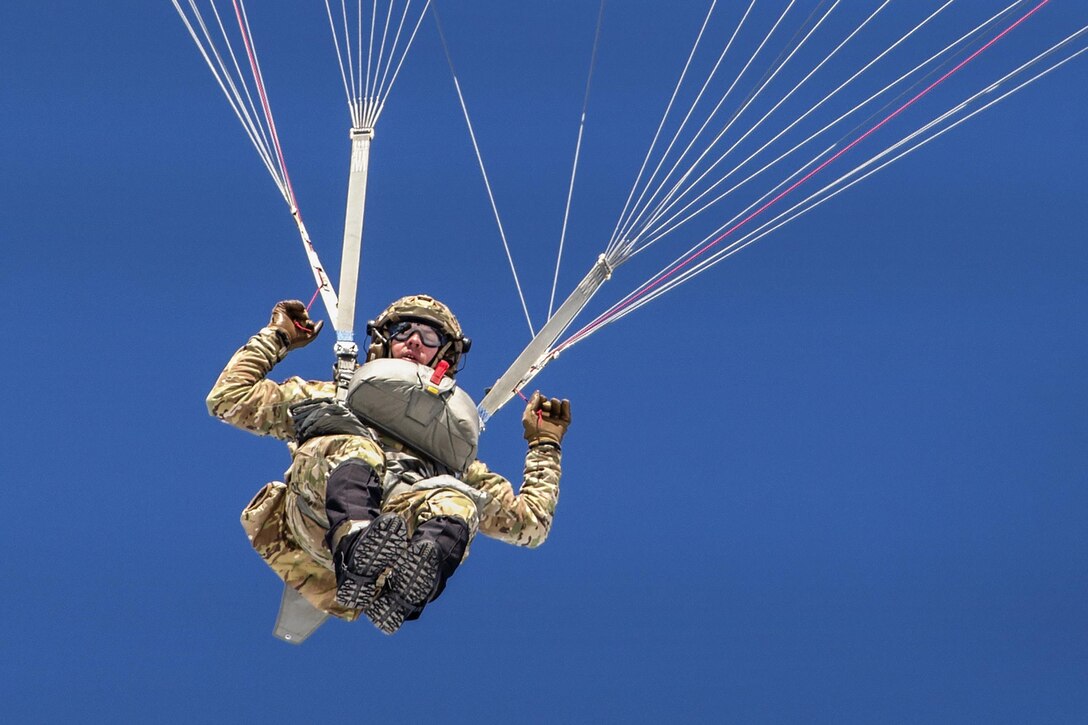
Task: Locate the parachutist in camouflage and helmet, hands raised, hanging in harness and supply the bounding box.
[207,295,570,643]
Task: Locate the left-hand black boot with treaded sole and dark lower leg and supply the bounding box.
[325,458,408,609]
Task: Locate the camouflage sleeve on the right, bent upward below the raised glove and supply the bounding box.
[465,445,561,546]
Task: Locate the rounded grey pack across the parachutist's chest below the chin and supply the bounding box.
[346,358,480,474]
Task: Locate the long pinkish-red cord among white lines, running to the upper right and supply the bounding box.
[554,0,1050,354]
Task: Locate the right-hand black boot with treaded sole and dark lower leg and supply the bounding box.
[366,516,469,635]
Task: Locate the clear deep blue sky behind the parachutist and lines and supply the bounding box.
[0,0,1088,723]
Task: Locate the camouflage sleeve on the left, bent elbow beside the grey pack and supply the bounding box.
[207,328,335,441]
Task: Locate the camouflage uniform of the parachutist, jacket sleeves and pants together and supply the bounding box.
[208,328,560,620]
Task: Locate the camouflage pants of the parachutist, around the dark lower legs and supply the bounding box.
[242,435,480,619]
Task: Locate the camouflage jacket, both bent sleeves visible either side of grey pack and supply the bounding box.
[207,328,560,546]
